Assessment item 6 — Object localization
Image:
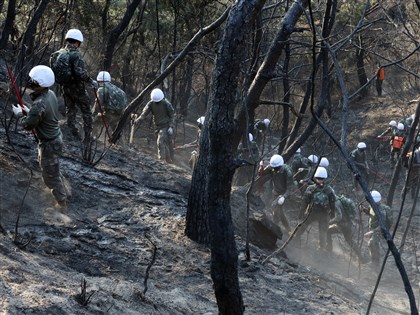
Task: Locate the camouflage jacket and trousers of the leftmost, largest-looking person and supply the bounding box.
[21,89,66,204]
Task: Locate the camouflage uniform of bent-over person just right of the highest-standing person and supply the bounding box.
[93,82,127,133]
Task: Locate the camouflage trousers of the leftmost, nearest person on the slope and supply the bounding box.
[38,135,67,202]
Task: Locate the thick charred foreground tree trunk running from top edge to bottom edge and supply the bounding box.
[189,0,265,314]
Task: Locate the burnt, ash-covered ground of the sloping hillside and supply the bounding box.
[0,85,420,315]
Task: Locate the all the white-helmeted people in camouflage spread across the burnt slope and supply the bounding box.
[13,29,420,265]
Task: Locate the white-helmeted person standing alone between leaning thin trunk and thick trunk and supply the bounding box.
[135,89,175,163]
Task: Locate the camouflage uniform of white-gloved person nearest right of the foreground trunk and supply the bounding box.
[255,164,293,231]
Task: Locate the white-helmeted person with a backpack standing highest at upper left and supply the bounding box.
[50,29,98,141]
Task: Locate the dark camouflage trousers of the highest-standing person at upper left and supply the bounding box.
[64,87,93,135]
